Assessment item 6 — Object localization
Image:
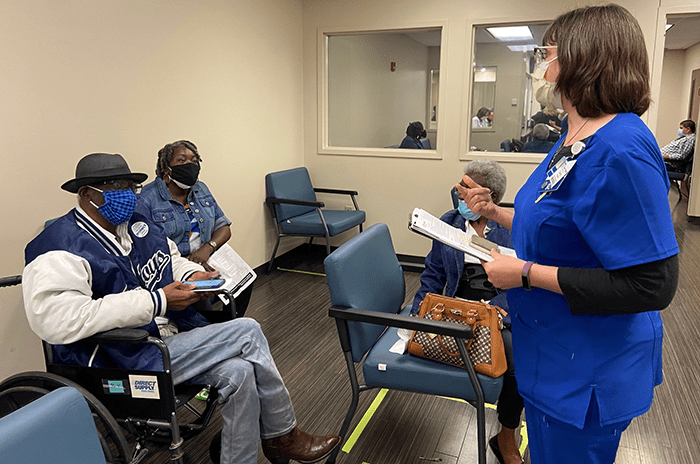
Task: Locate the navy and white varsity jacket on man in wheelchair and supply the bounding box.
[22,207,208,370]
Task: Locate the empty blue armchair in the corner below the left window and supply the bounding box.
[265,167,365,273]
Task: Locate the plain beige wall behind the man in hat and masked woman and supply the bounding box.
[0,0,303,379]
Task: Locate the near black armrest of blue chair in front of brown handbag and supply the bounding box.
[328,306,474,340]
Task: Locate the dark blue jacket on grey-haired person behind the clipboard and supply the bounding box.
[411,209,513,314]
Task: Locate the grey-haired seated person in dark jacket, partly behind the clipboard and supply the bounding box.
[411,160,523,464]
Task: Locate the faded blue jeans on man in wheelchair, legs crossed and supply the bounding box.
[165,317,296,464]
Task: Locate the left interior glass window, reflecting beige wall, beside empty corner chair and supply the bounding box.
[325,27,442,150]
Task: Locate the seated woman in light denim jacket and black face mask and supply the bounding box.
[137,140,253,316]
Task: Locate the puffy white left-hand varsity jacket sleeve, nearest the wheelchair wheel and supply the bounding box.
[22,251,165,344]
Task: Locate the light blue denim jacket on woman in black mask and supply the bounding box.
[136,177,231,256]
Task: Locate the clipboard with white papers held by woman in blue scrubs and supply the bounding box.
[408,208,515,261]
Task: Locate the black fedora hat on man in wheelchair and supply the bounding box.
[61,153,148,193]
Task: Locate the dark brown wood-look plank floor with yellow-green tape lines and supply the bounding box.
[134,191,700,464]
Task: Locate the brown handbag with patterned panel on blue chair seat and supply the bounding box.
[408,293,507,377]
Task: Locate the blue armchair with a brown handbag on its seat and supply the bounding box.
[324,223,503,464]
